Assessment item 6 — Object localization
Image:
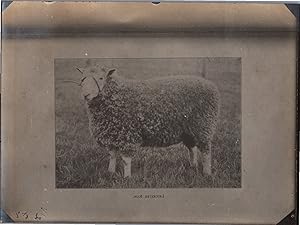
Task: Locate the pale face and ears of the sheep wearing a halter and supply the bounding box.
[77,66,116,101]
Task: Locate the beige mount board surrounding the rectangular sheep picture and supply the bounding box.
[1,1,296,224]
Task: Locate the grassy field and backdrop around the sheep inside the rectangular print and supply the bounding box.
[54,58,241,188]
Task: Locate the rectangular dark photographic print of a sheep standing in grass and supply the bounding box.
[54,57,241,188]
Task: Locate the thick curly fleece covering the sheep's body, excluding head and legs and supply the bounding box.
[85,76,219,148]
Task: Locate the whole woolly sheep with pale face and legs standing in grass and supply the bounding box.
[77,66,220,177]
